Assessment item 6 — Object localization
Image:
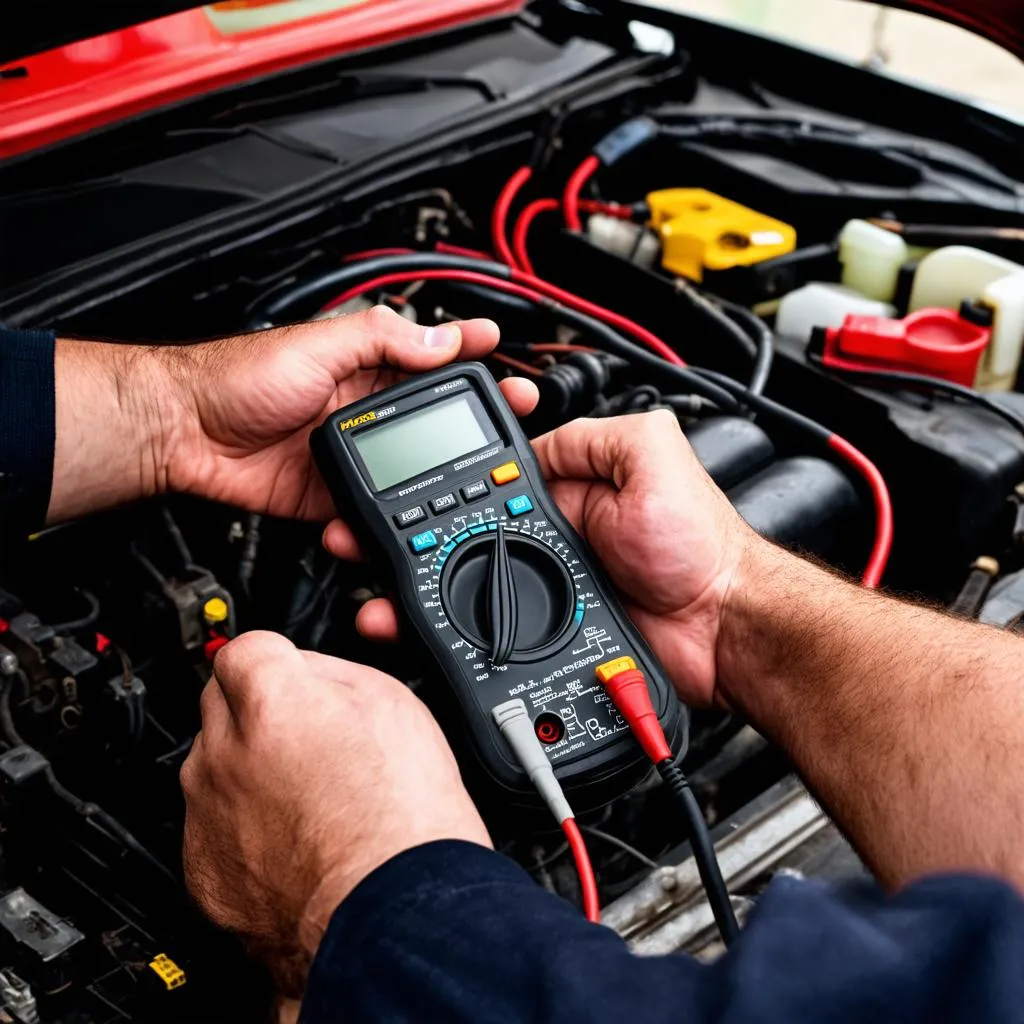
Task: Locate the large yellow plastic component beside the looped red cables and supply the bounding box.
[647,188,797,282]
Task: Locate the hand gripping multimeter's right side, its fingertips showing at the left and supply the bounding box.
[344,412,757,705]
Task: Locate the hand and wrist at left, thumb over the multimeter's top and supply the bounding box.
[48,306,537,521]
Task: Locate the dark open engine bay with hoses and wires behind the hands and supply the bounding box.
[0,3,1024,1024]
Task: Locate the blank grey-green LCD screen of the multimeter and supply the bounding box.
[352,395,489,490]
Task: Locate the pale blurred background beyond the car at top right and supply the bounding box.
[648,0,1024,119]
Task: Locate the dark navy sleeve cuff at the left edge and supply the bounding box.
[0,328,56,544]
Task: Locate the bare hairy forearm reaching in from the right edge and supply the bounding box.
[718,544,1024,887]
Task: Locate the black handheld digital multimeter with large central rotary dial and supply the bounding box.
[310,362,687,803]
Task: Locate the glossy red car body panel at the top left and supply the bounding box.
[0,0,523,158]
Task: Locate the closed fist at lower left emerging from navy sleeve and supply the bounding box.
[181,633,490,995]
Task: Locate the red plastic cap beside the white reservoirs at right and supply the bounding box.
[821,309,992,387]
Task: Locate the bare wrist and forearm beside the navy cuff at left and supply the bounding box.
[47,339,192,522]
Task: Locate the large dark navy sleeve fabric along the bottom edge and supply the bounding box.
[300,842,1024,1024]
